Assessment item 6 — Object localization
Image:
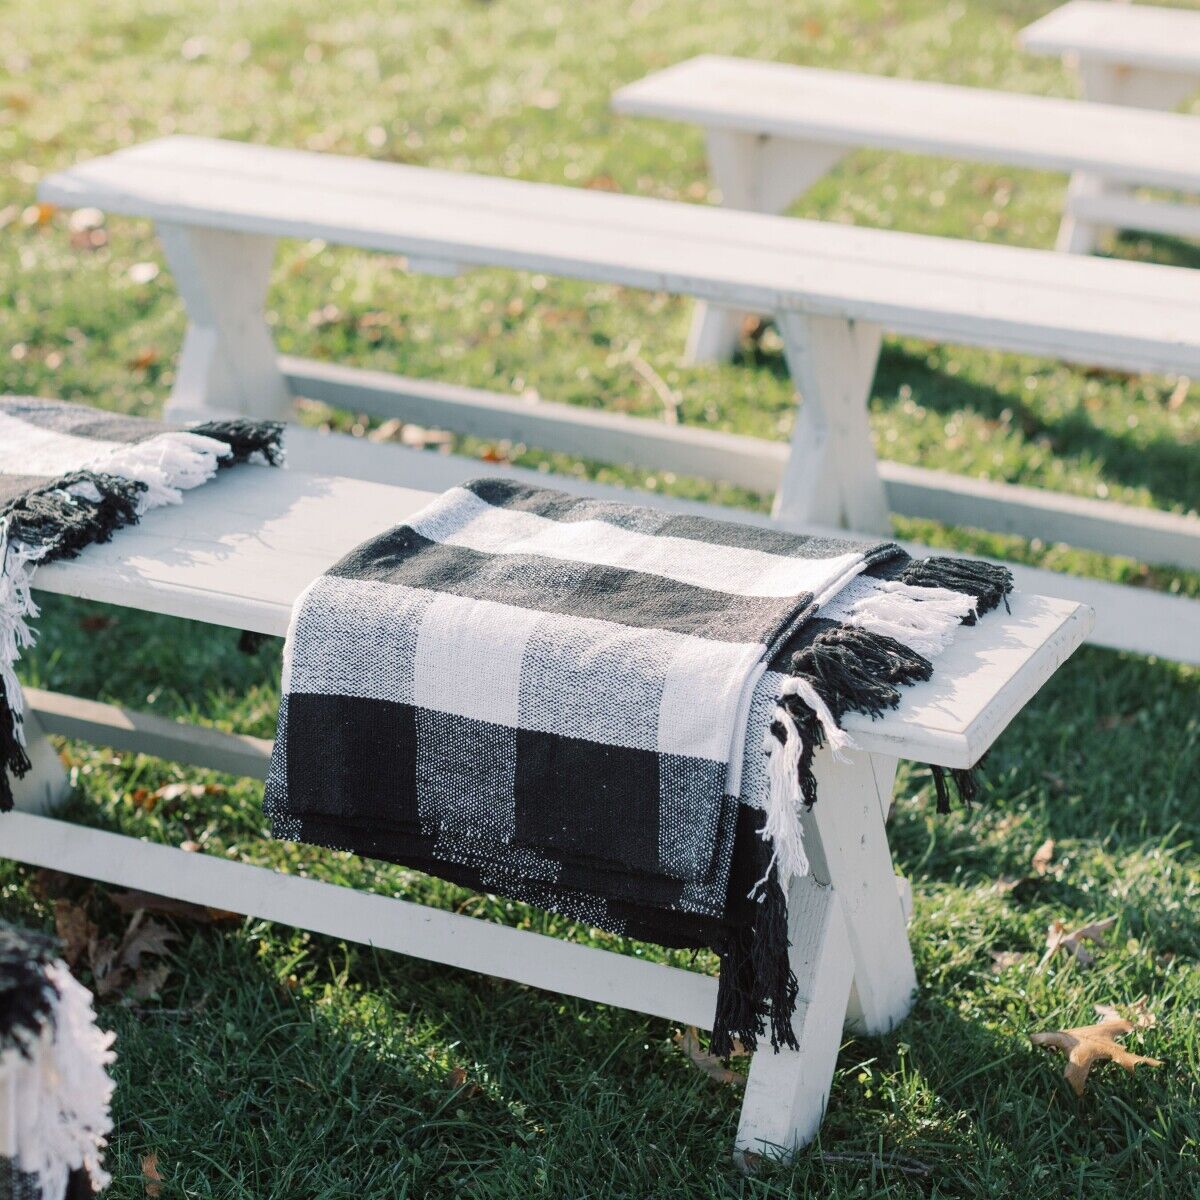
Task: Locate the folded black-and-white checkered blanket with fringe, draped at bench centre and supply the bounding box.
[265,479,1012,1052]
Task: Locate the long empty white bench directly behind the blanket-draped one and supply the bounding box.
[40,138,1200,662]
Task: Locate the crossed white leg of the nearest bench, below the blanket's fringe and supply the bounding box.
[734,752,917,1164]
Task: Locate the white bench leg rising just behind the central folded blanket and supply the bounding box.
[774,313,892,535]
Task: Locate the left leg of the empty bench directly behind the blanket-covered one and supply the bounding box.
[158,224,290,420]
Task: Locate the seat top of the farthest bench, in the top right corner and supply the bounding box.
[1020,0,1200,77]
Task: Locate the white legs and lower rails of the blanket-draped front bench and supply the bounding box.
[7,691,916,1154]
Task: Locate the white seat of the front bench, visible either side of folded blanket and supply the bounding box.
[35,456,1091,767]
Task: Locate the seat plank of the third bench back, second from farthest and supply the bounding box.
[613,54,1200,192]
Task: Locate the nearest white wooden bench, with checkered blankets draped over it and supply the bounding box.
[0,456,1091,1152]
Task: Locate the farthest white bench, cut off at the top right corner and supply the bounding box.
[1020,0,1200,253]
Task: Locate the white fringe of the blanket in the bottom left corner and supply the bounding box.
[0,962,116,1196]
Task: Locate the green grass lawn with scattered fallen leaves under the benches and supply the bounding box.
[0,0,1200,1200]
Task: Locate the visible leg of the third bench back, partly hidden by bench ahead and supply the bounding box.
[684,130,846,364]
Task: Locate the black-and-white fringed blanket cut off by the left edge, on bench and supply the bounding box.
[0,396,282,811]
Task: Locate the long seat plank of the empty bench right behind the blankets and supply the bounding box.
[40,137,1200,376]
